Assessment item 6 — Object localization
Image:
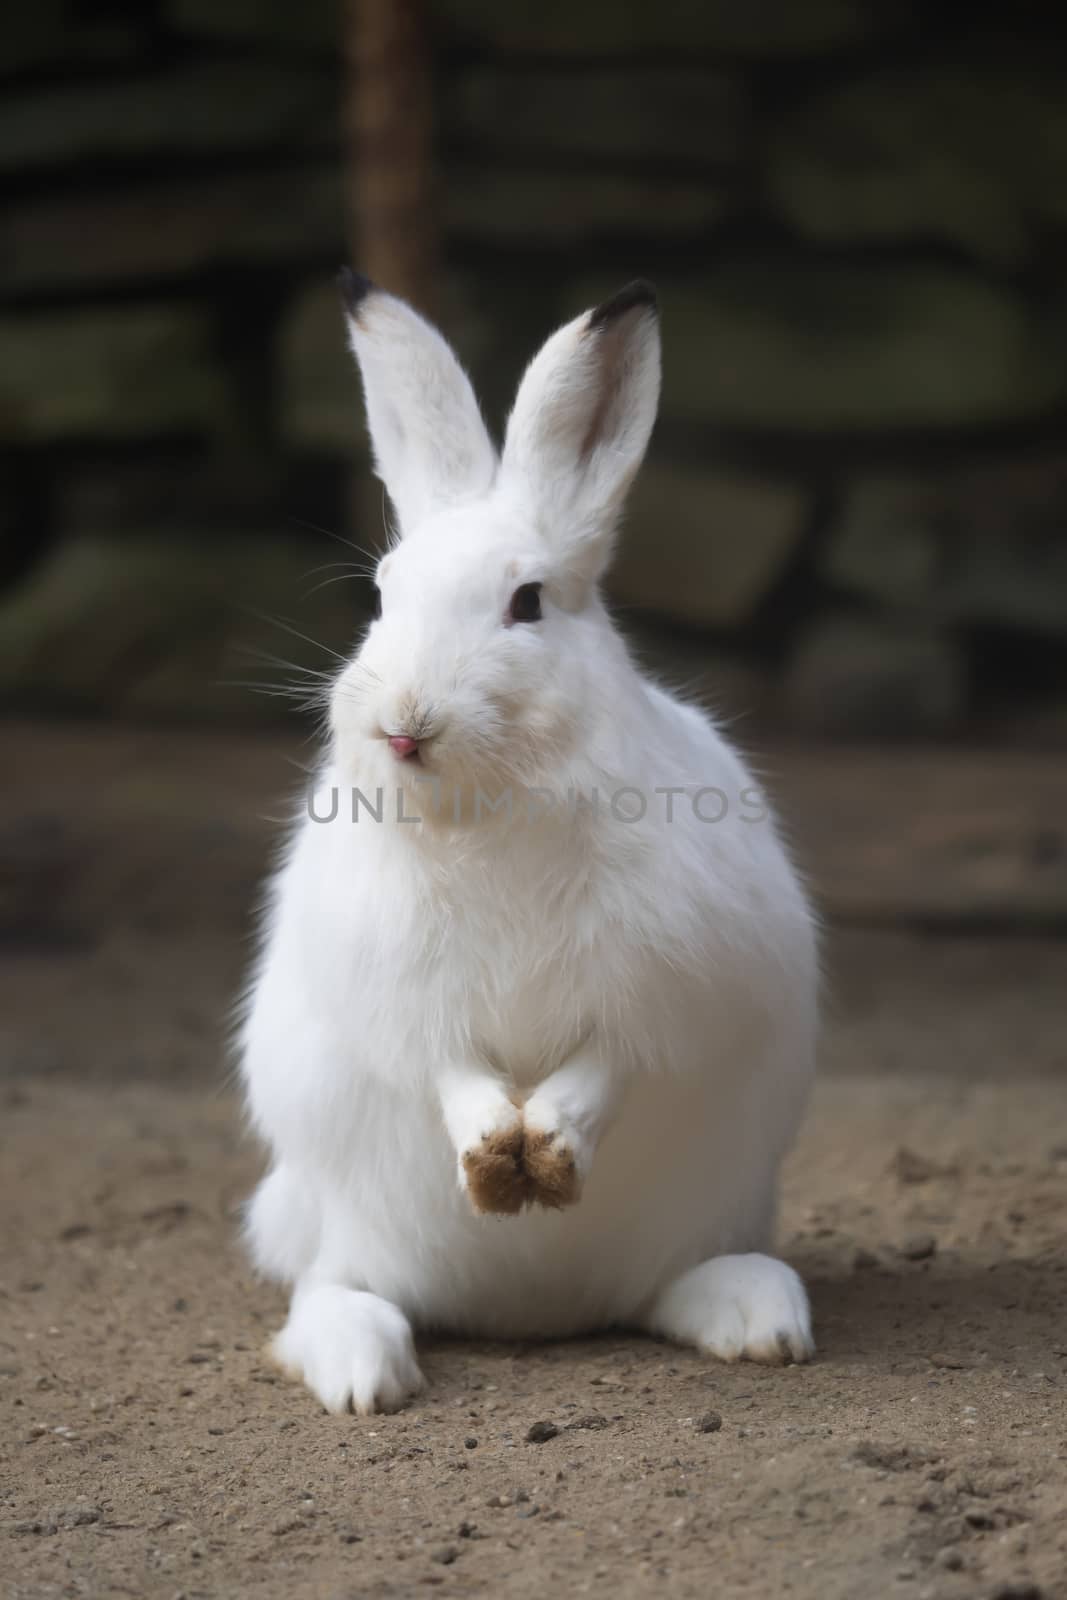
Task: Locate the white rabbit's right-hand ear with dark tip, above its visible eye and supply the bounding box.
[502,282,659,581]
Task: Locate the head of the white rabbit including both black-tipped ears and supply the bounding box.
[331,274,659,812]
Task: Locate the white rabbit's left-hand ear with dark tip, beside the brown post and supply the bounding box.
[341,267,496,531]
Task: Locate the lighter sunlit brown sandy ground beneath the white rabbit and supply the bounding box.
[0,1078,1067,1600]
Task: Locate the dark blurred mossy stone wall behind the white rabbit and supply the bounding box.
[0,0,1067,738]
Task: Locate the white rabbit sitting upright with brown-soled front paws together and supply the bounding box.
[242,274,817,1411]
